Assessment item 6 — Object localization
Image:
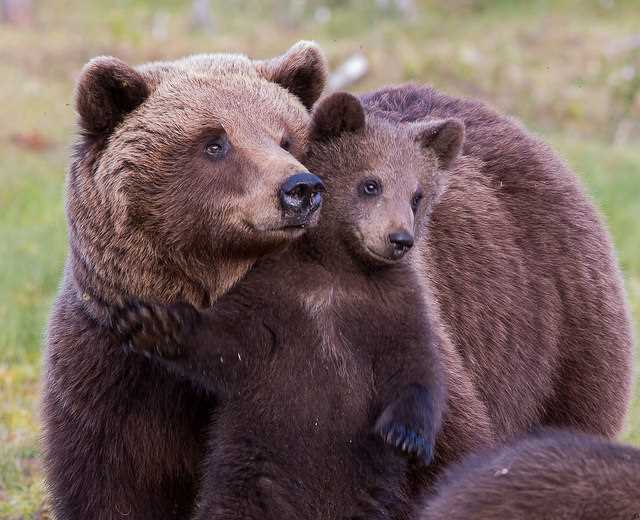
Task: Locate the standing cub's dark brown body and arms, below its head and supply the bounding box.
[117,245,442,520]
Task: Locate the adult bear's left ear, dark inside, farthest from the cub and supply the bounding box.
[76,56,149,135]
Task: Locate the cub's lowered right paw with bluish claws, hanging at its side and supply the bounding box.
[375,385,440,465]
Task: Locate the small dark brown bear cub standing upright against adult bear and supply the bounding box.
[113,93,464,519]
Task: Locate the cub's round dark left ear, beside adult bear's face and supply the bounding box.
[310,92,365,141]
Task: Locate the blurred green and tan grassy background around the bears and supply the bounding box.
[0,0,640,519]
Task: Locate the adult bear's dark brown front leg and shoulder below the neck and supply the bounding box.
[42,307,215,520]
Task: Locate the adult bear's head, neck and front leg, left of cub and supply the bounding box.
[42,42,326,520]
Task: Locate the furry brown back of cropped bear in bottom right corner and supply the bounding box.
[420,431,640,520]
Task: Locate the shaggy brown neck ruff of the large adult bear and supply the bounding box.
[66,142,252,316]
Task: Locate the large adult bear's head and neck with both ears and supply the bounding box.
[67,42,326,306]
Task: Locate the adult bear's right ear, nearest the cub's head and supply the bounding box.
[254,41,328,110]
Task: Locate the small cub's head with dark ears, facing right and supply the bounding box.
[304,92,464,265]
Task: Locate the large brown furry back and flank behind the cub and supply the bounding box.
[360,85,633,440]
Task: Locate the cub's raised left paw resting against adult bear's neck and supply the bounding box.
[111,302,198,359]
